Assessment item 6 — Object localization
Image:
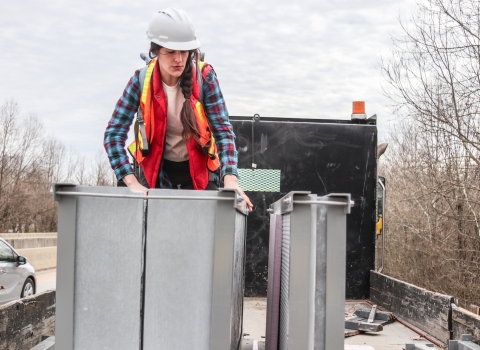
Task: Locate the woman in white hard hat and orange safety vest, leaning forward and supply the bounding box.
[104,8,253,211]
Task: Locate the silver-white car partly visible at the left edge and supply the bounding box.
[0,238,36,304]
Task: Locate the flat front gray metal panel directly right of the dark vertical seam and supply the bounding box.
[143,190,217,350]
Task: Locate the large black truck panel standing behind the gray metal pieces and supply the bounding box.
[230,117,377,299]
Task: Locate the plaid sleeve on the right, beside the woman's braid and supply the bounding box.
[203,69,238,178]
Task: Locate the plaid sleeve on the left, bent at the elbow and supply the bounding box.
[103,70,140,180]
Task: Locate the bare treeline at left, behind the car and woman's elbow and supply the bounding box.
[0,100,114,232]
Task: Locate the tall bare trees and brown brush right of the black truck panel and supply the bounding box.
[380,0,480,308]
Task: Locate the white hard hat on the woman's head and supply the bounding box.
[147,7,200,50]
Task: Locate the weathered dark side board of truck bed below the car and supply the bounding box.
[0,290,56,350]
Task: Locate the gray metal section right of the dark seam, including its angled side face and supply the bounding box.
[143,190,246,350]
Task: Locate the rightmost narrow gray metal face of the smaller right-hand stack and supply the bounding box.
[325,199,347,349]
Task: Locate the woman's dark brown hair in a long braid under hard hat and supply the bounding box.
[148,42,202,146]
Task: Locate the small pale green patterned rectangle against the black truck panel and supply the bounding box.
[238,169,281,192]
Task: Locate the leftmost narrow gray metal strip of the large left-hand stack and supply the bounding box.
[53,185,77,350]
